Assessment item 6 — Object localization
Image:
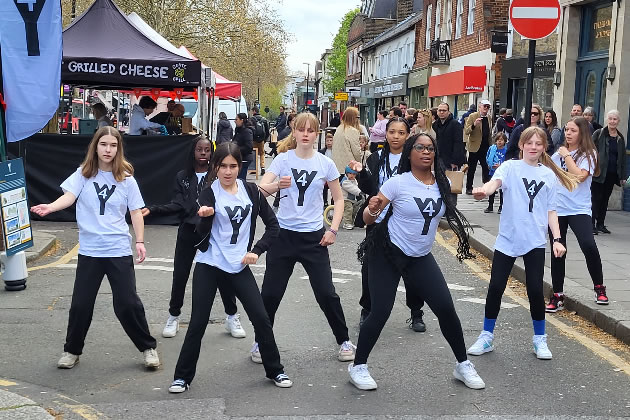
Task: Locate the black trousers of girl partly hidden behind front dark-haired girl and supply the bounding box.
[168,223,238,316]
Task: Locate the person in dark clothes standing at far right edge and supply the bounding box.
[591,109,626,233]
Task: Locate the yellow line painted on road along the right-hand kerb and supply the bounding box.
[435,233,630,376]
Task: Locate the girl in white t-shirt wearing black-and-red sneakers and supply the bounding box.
[545,117,608,312]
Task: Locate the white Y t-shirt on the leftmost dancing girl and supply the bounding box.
[61,167,144,257]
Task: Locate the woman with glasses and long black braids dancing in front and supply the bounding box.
[348,133,485,390]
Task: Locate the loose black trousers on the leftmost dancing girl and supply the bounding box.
[63,254,157,355]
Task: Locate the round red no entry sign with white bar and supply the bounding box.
[510,0,560,39]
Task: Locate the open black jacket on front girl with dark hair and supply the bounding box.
[196,182,280,256]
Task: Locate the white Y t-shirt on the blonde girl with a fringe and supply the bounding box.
[267,150,339,232]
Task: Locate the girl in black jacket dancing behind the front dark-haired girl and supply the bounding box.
[142,138,246,338]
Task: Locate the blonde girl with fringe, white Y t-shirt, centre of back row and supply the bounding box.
[252,112,354,361]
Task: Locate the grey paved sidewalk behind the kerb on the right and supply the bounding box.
[442,179,630,344]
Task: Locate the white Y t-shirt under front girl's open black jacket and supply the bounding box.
[195,179,252,273]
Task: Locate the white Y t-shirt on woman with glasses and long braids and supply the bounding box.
[381,172,446,257]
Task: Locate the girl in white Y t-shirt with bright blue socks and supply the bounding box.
[468,127,576,359]
